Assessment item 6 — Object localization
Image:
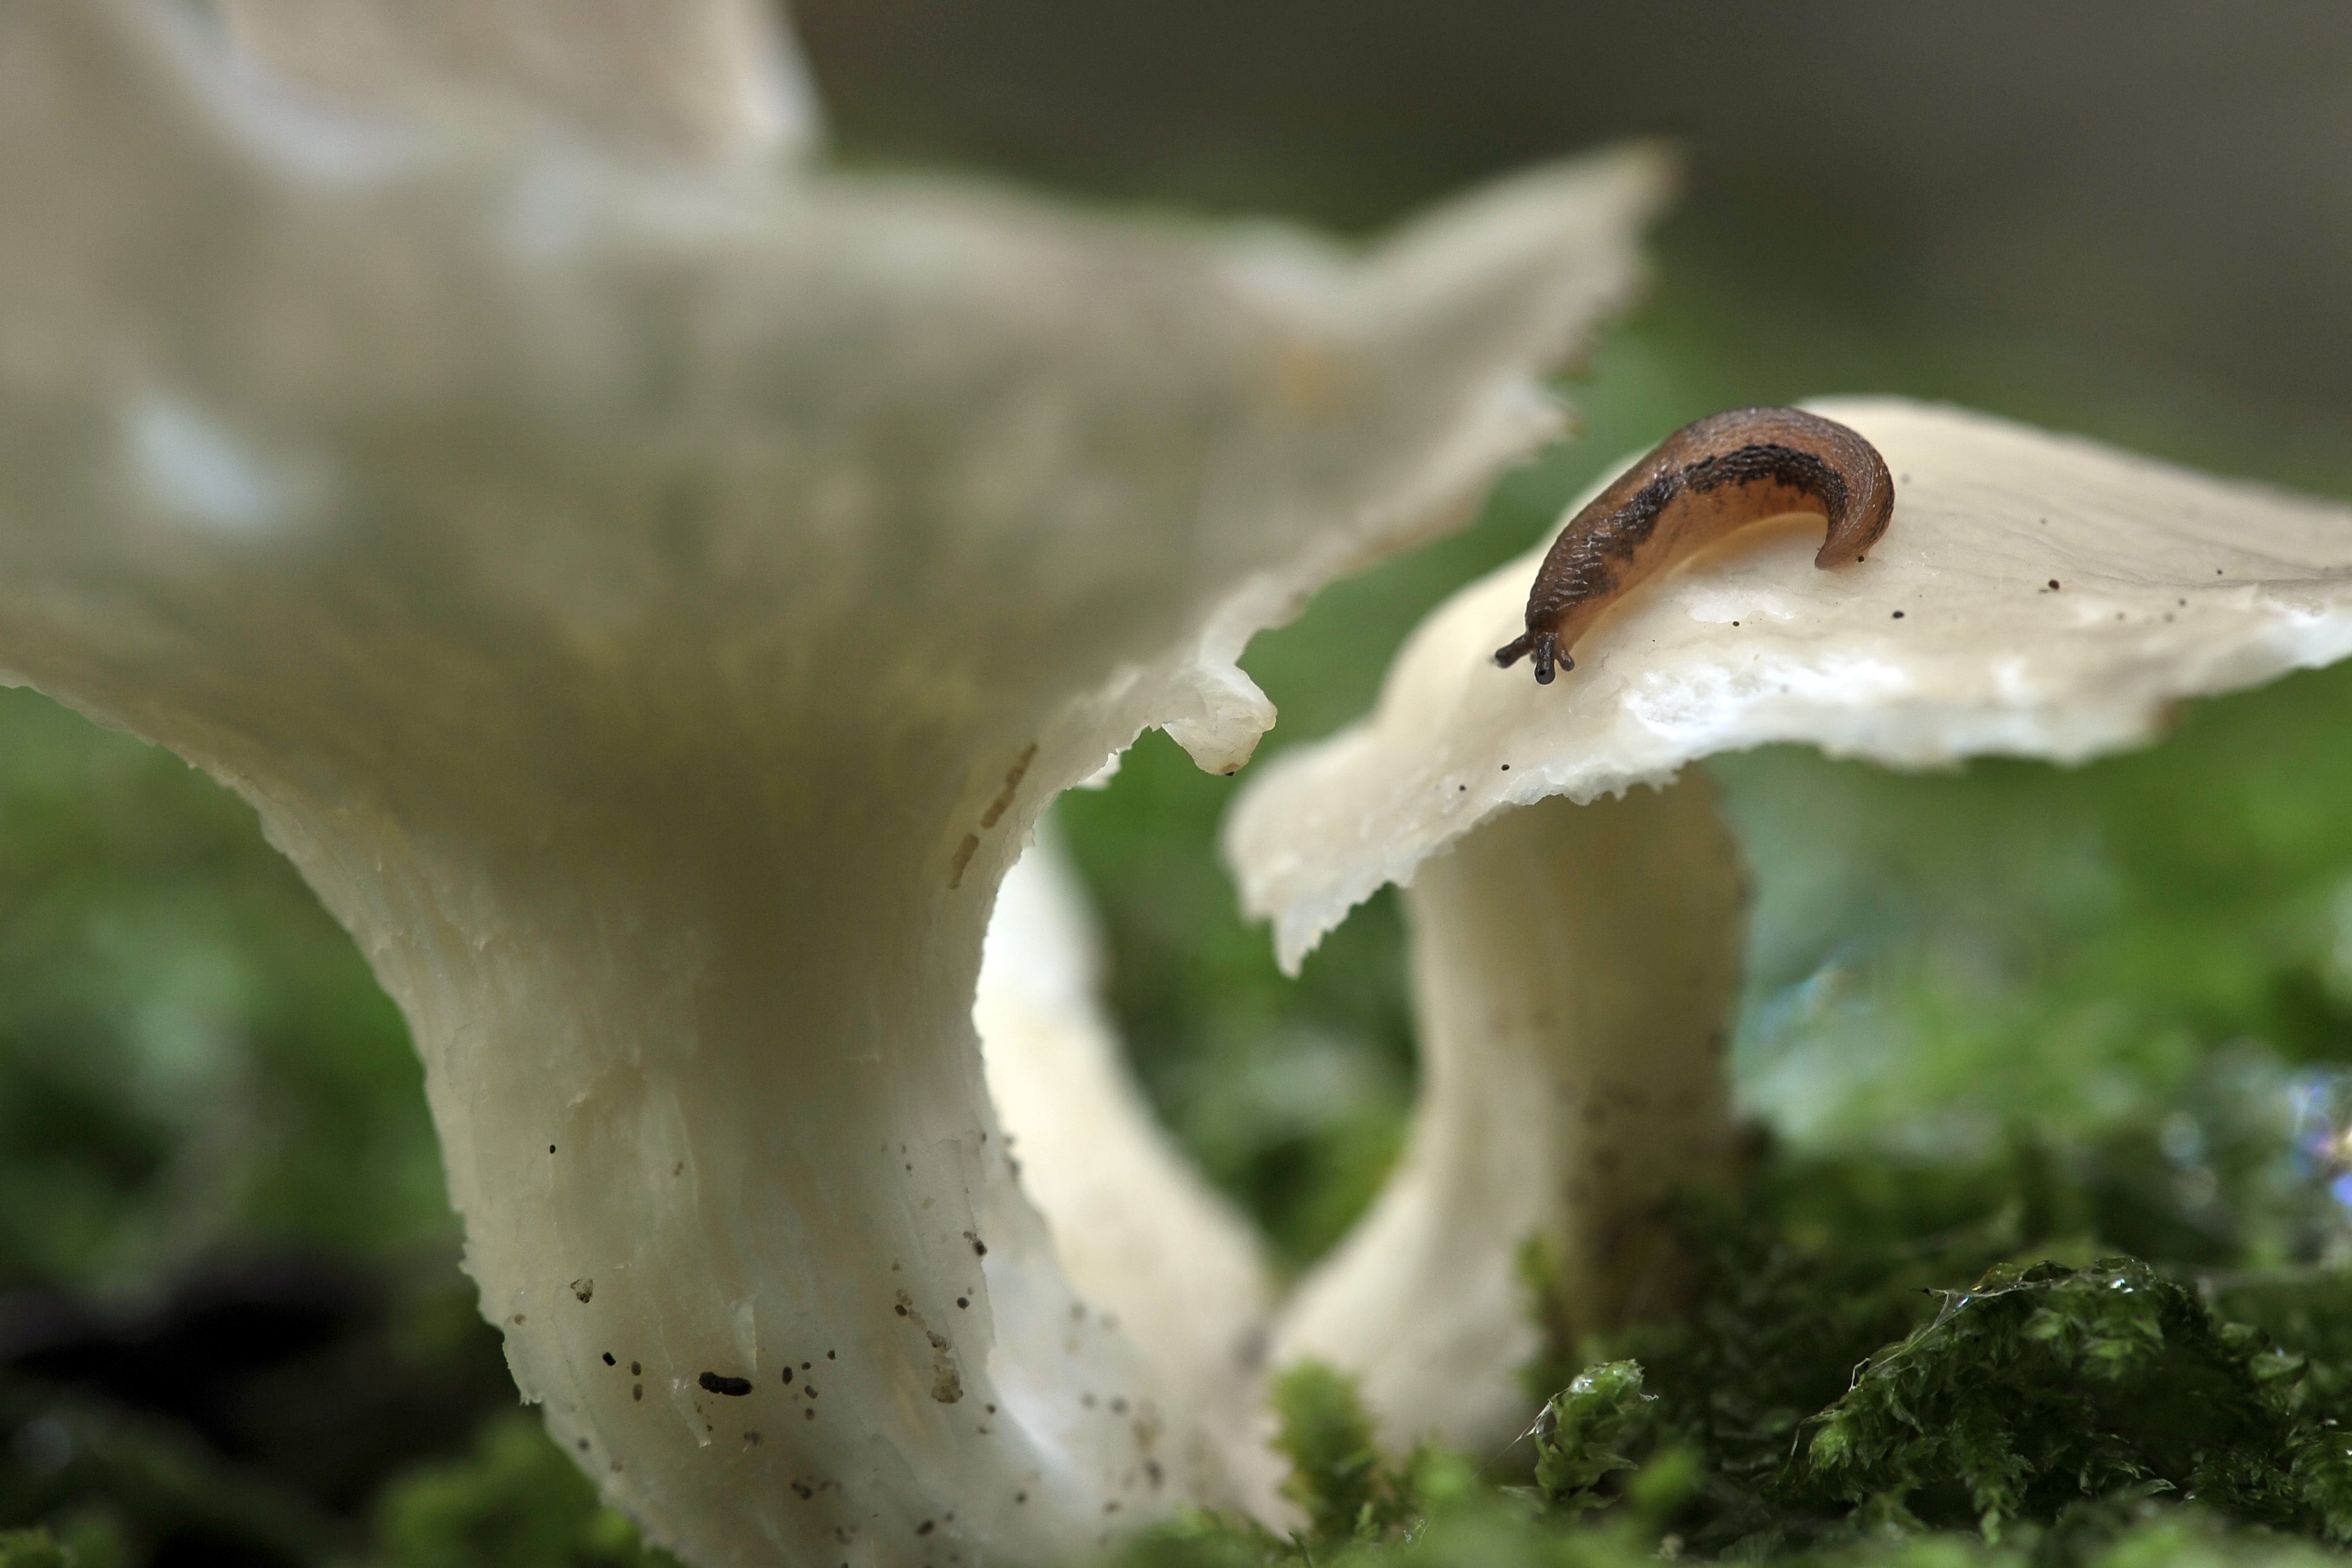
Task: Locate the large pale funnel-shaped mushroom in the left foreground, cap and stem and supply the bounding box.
[0,0,1663,1563]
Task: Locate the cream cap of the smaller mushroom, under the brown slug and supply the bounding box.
[1226,397,2352,969]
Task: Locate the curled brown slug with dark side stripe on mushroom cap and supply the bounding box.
[1494,409,1896,684]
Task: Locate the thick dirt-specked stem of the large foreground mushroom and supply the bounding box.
[250,736,1235,1566]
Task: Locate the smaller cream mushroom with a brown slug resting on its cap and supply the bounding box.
[1226,400,2352,1446]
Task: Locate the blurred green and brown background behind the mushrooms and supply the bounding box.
[13,5,2352,1566]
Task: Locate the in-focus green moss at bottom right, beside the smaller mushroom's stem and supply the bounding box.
[1100,1091,2352,1568]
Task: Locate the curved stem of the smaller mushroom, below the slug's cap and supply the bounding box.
[1275,771,1740,1450]
